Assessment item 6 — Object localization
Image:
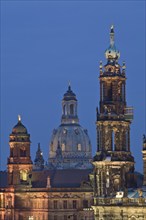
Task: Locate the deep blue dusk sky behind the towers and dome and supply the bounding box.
[0,1,146,172]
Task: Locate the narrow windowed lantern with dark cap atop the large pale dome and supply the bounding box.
[61,83,79,124]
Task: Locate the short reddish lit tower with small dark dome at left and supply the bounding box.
[7,116,32,186]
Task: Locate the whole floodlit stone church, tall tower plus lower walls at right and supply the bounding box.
[91,26,146,220]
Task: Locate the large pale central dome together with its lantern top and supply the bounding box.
[49,85,92,169]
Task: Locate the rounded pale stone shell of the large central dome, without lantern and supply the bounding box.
[50,124,91,158]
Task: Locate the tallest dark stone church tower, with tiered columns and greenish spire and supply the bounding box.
[93,26,134,197]
